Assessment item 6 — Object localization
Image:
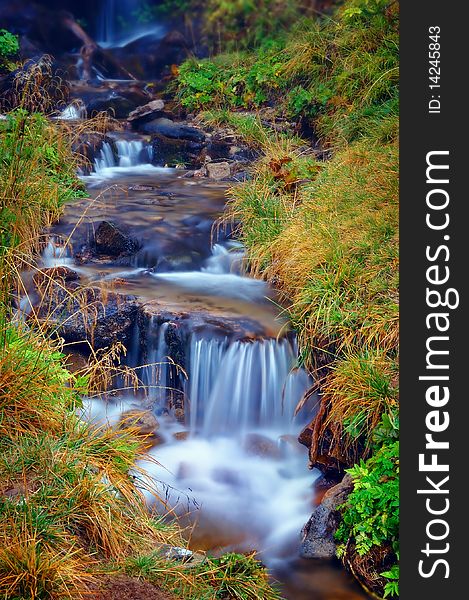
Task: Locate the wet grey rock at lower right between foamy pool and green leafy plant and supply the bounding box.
[300,474,353,559]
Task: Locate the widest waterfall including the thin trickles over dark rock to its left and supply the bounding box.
[132,317,311,437]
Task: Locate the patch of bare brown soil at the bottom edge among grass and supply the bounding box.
[87,575,177,600]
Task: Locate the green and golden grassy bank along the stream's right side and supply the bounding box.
[176,0,399,597]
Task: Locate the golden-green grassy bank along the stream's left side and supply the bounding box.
[0,54,279,600]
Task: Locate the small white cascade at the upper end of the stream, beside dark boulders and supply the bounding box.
[93,140,152,175]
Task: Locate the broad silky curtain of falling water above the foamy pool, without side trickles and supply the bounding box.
[187,336,311,436]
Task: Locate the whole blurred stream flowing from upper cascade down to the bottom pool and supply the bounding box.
[47,137,365,600]
